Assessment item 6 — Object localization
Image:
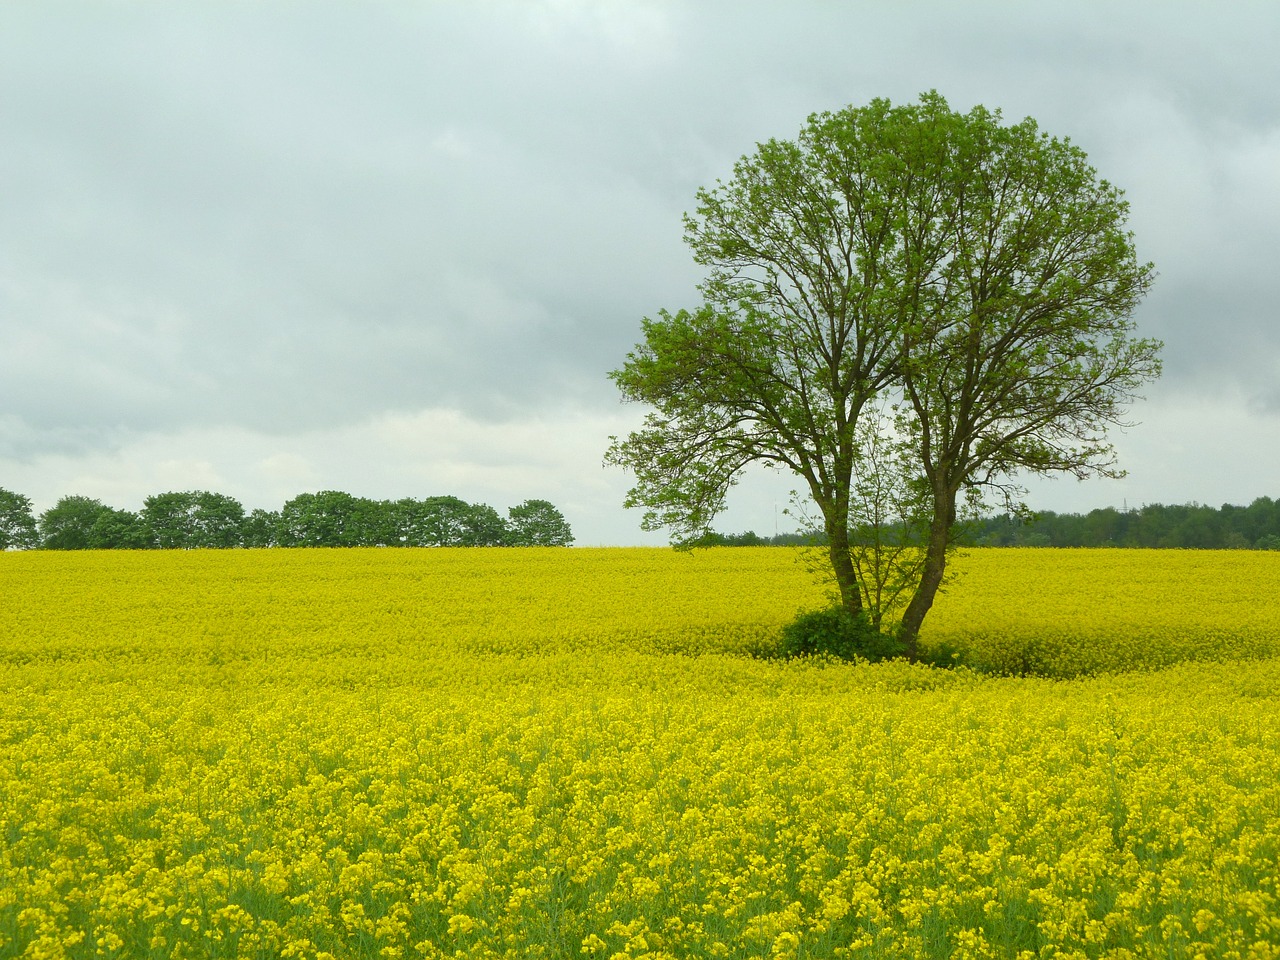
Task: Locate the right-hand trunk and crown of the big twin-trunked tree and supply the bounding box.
[865,95,1161,650]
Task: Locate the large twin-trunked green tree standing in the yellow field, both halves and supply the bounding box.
[605,92,1160,655]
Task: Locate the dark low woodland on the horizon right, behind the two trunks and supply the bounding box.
[689,497,1280,550]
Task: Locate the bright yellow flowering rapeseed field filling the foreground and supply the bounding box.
[0,548,1280,960]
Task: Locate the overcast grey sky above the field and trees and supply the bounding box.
[0,0,1280,544]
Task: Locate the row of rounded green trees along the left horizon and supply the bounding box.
[0,489,573,550]
